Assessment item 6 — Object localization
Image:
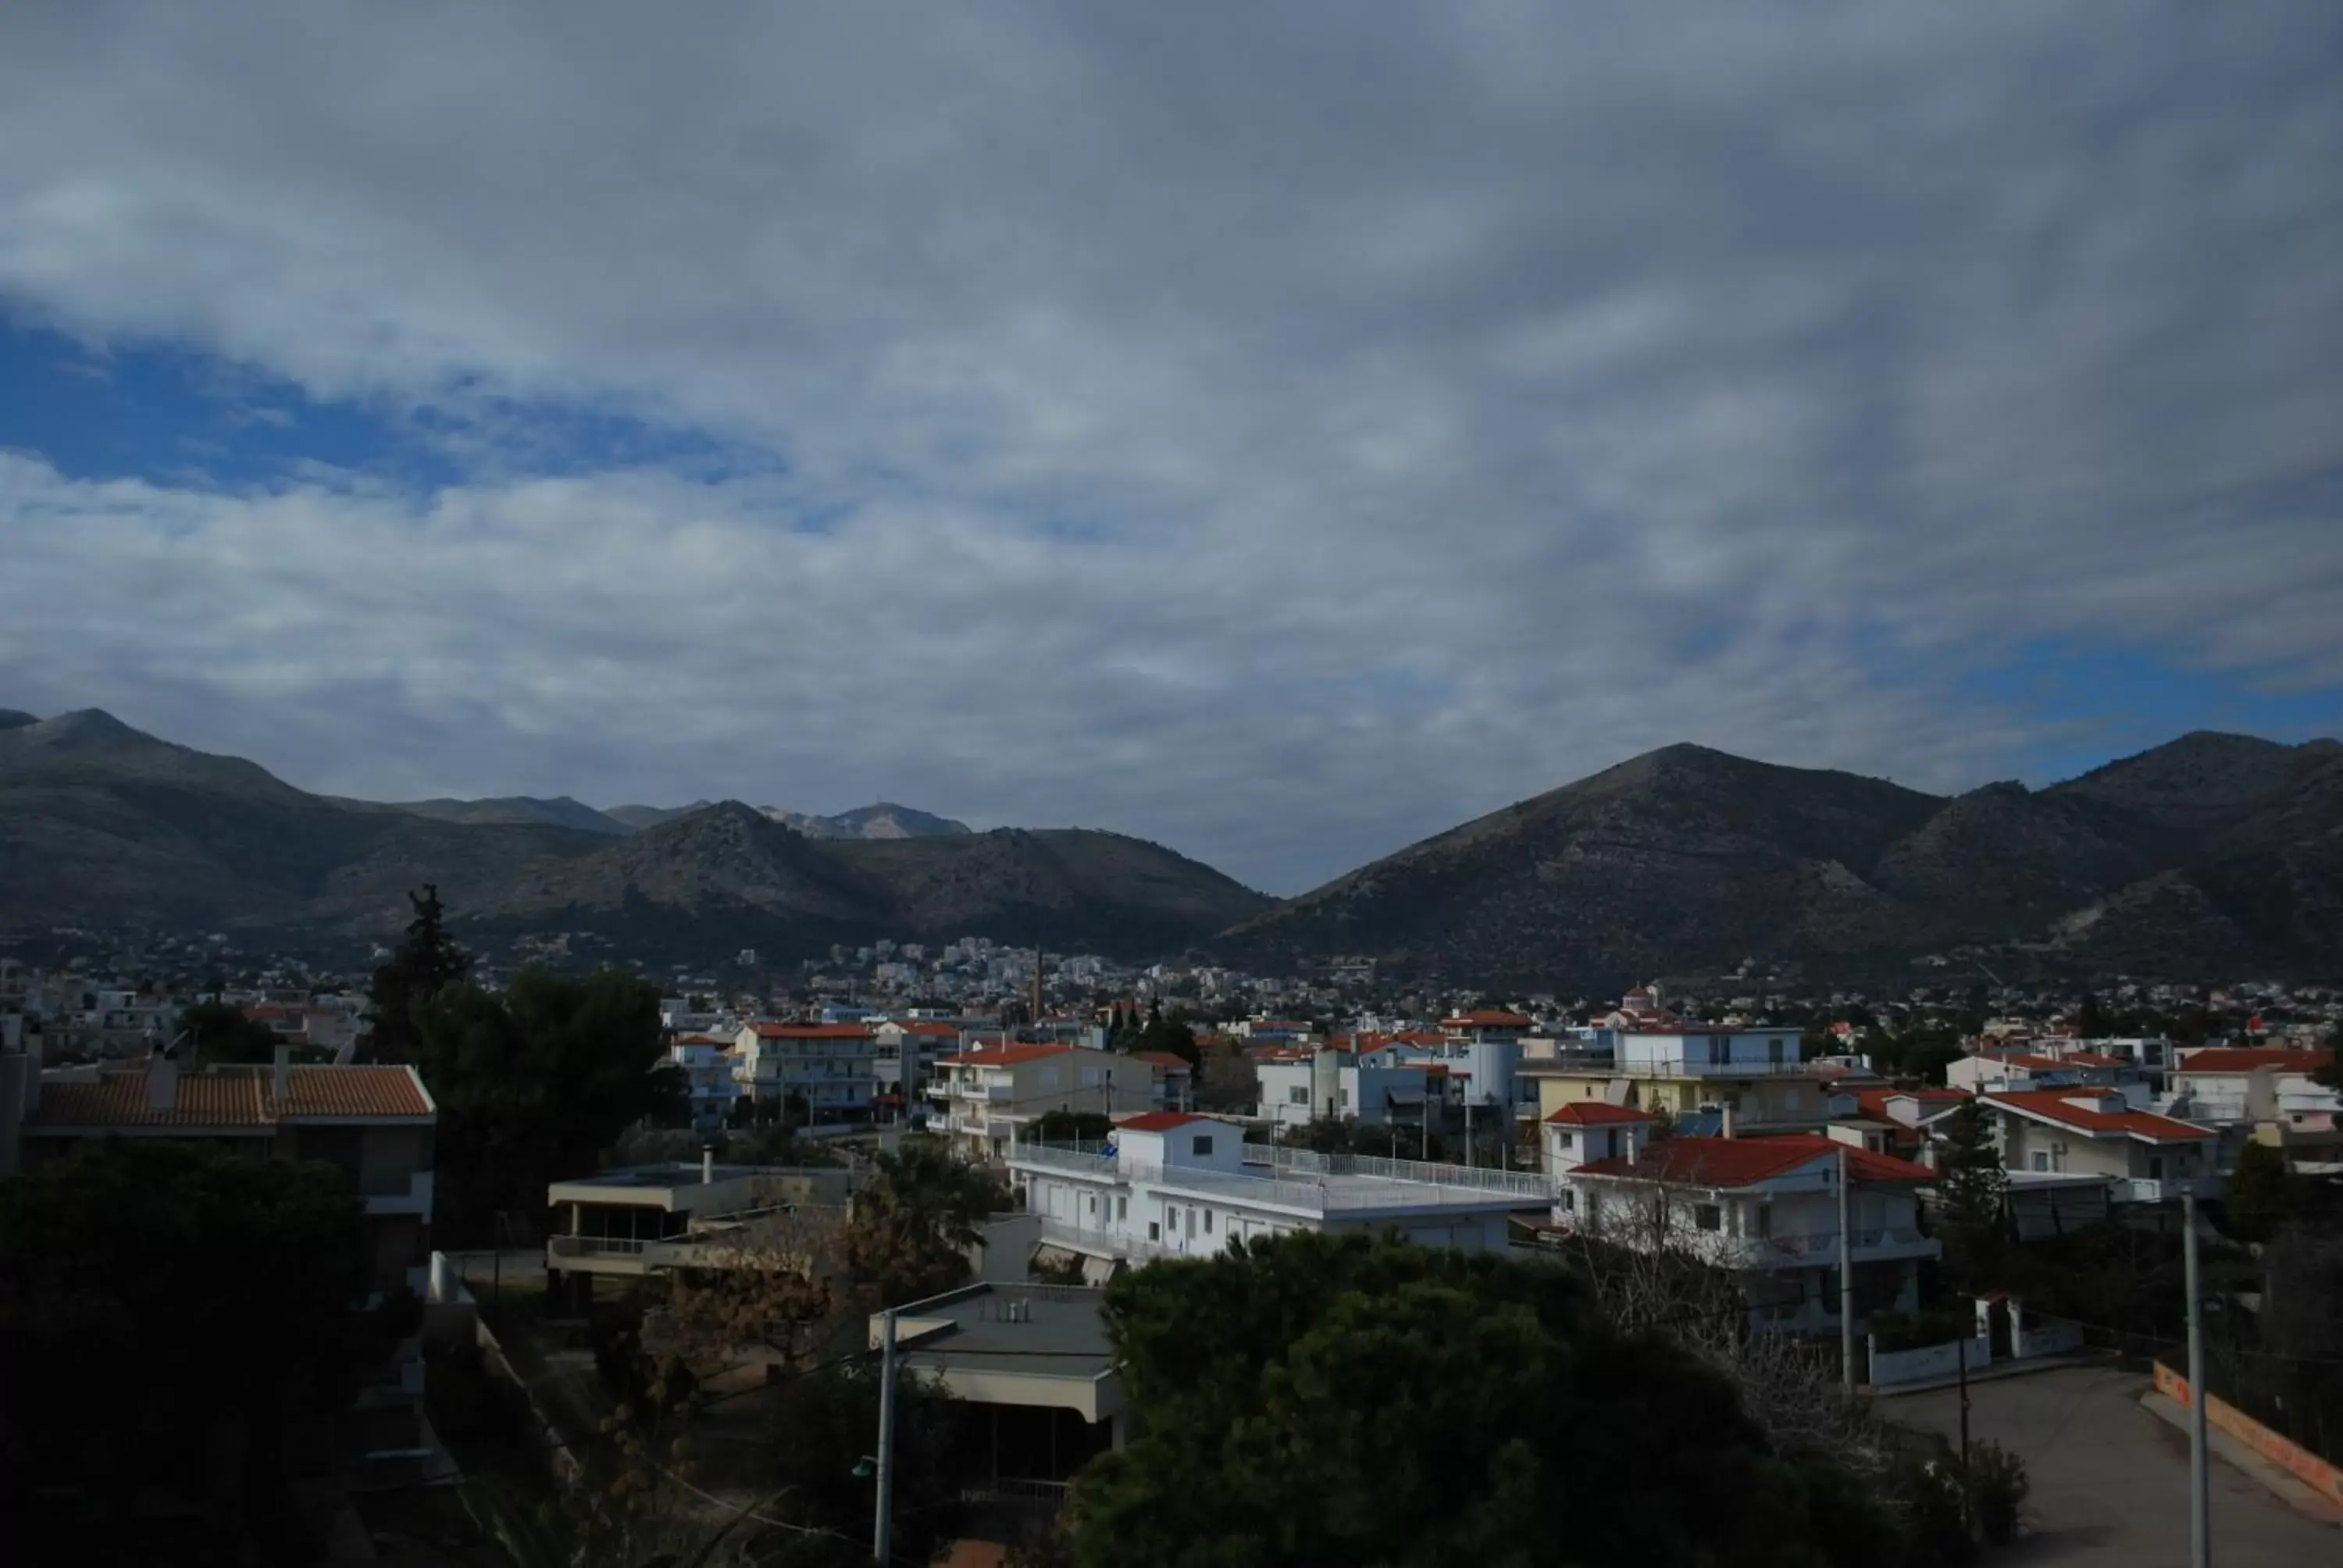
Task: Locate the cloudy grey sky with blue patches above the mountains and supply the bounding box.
[0,0,2343,893]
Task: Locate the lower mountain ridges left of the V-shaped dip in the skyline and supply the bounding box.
[0,710,1268,957]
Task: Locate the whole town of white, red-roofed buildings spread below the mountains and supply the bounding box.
[0,891,2343,1561]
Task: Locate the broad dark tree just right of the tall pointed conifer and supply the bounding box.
[415,971,684,1245]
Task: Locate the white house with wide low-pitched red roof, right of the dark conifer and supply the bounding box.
[1982,1088,2219,1203]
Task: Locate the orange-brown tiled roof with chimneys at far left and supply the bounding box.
[26,1067,438,1132]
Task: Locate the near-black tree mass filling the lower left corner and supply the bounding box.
[0,1139,396,1563]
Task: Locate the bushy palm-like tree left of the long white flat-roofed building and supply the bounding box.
[841,1139,1010,1308]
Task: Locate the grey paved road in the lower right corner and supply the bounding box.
[1877,1367,2343,1568]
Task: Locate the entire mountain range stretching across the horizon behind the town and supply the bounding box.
[0,710,2343,987]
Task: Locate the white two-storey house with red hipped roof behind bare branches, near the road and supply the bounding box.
[1553,1132,1942,1331]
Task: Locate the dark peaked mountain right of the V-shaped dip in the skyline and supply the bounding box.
[1221,733,2343,985]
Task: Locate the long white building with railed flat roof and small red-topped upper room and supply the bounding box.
[1007,1111,1549,1278]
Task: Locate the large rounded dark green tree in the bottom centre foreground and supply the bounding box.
[1071,1233,1895,1568]
